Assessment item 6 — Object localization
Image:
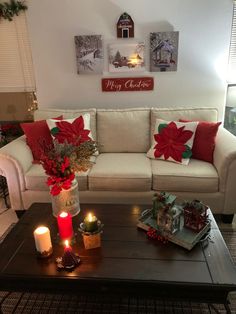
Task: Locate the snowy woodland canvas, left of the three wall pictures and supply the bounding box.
[75,35,104,74]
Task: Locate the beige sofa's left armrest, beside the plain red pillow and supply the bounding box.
[0,135,33,209]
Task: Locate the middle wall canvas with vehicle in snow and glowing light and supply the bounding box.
[108,42,145,72]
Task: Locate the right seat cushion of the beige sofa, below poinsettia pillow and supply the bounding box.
[151,159,219,193]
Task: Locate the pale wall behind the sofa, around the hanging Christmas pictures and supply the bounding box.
[26,0,233,119]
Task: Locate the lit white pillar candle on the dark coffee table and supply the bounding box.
[34,226,52,254]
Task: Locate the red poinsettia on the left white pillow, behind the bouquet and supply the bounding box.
[54,116,91,145]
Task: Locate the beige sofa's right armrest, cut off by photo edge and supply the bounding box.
[214,128,236,214]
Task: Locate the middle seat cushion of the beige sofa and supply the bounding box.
[88,153,152,191]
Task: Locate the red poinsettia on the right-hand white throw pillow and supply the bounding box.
[154,122,193,162]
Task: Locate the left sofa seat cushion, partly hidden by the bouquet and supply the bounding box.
[25,165,89,191]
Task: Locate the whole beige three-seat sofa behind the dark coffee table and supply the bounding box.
[0,108,236,220]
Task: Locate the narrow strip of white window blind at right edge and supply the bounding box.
[228,0,236,83]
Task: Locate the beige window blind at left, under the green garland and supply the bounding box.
[0,12,35,92]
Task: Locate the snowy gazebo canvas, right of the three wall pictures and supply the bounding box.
[150,32,179,72]
